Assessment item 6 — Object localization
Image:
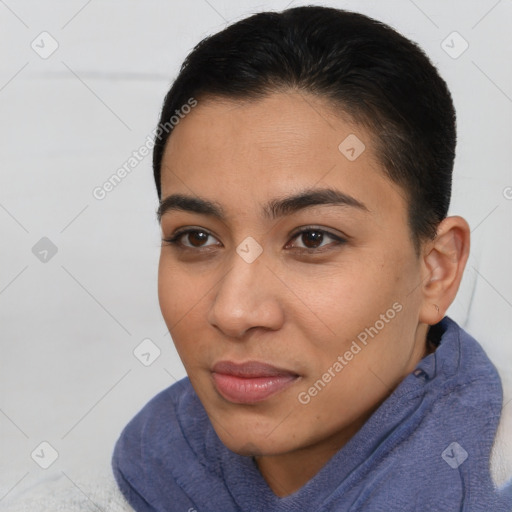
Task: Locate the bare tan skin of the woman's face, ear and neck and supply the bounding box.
[158,91,469,496]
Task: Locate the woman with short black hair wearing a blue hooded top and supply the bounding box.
[113,7,512,512]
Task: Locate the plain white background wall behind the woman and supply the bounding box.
[0,0,512,501]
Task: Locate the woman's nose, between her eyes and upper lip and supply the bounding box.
[208,248,284,339]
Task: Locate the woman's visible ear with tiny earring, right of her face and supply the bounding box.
[419,216,470,325]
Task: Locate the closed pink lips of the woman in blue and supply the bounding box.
[212,361,299,404]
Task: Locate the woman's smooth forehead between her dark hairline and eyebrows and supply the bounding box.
[161,92,406,226]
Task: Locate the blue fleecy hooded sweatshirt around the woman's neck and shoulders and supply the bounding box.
[112,317,512,512]
